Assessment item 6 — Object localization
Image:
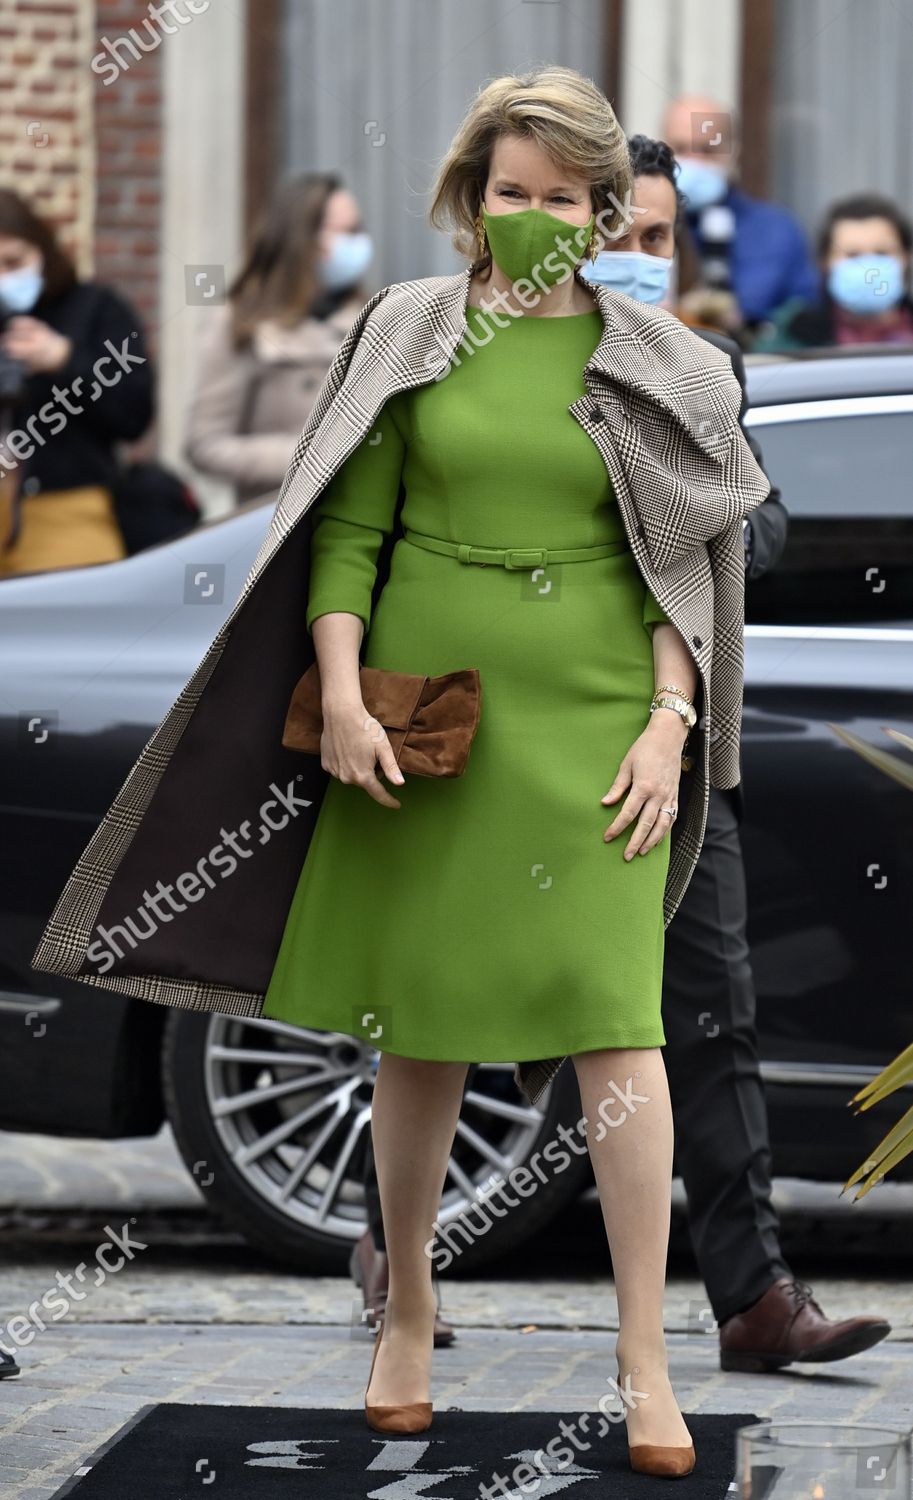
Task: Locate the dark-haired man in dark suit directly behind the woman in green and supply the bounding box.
[351,135,891,1371]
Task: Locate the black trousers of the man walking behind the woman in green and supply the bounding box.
[364,788,792,1323]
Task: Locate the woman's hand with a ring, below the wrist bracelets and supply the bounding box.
[601,708,687,860]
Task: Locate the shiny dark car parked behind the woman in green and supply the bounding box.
[0,350,913,1271]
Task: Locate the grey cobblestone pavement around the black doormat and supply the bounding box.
[0,1133,913,1500]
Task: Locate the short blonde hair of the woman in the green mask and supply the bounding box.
[429,66,634,269]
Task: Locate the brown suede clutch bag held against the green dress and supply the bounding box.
[282,662,481,776]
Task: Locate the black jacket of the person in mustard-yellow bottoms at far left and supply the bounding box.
[0,282,153,495]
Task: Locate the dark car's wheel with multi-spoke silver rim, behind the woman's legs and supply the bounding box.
[162,1011,592,1275]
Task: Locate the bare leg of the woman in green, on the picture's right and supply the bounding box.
[574,1047,691,1448]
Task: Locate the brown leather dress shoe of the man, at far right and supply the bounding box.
[720,1277,891,1374]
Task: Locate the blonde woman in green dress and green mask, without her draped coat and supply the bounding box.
[262,69,697,1473]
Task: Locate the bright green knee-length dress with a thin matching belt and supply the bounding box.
[264,306,670,1062]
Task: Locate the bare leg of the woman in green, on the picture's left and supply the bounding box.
[366,1052,469,1406]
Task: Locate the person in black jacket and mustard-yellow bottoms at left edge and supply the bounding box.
[0,189,153,576]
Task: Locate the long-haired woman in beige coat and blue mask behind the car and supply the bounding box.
[184,173,373,504]
